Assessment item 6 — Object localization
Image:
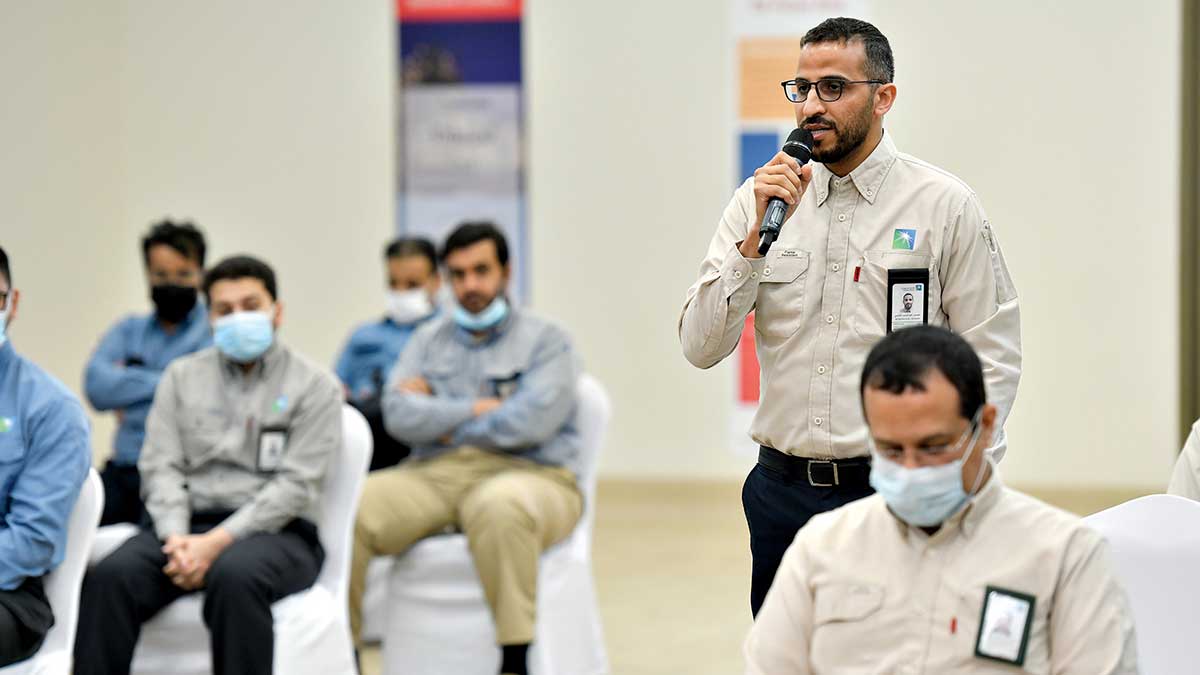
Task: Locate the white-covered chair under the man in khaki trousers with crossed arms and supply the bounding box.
[379,375,612,675]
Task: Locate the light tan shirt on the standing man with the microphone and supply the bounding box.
[679,135,1021,459]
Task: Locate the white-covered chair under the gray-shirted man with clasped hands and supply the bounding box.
[86,406,372,675]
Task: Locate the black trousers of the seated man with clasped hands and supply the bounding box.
[74,513,325,675]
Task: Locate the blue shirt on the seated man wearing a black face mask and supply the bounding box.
[84,303,212,466]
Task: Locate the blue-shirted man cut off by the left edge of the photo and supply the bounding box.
[0,243,91,667]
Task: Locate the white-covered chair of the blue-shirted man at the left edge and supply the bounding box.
[0,470,104,675]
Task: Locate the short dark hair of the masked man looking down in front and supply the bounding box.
[859,325,988,419]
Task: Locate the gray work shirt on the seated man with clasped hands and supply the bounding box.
[138,342,342,539]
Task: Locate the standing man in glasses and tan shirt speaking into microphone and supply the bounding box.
[679,18,1021,614]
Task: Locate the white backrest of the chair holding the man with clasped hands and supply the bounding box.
[316,405,372,603]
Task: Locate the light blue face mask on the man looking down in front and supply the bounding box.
[871,416,986,527]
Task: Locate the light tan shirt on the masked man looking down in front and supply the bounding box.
[745,473,1138,675]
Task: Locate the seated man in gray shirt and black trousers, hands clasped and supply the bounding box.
[74,256,342,675]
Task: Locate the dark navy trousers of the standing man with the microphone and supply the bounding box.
[742,447,875,616]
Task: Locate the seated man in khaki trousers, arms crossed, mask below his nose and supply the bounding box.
[350,223,583,675]
